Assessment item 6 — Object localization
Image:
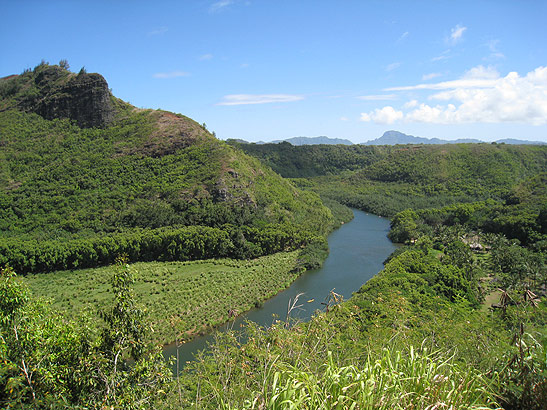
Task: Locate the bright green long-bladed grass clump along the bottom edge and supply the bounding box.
[229,348,498,410]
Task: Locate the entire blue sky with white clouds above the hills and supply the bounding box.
[0,0,547,143]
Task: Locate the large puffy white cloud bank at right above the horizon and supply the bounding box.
[361,66,547,125]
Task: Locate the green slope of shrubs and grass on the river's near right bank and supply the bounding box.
[172,203,547,409]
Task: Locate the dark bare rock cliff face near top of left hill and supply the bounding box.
[33,70,114,128]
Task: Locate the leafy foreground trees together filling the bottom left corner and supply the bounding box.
[0,264,171,409]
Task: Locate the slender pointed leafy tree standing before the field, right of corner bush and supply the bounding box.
[86,258,172,409]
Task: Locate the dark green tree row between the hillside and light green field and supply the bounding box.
[0,219,325,272]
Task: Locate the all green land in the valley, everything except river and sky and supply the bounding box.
[0,62,547,410]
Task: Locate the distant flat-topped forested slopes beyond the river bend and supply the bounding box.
[230,141,547,216]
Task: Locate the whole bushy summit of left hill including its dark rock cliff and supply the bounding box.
[0,64,114,128]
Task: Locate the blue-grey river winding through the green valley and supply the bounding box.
[164,210,395,368]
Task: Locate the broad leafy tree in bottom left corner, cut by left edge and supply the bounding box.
[0,268,83,409]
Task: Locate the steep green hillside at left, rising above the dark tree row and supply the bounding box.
[0,64,333,270]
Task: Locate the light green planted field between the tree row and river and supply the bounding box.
[25,252,299,343]
